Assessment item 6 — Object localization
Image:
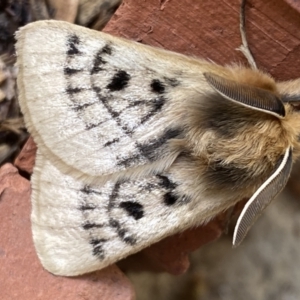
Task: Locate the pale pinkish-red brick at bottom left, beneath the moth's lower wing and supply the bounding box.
[0,164,135,300]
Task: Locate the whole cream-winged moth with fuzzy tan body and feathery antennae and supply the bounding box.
[16,15,300,275]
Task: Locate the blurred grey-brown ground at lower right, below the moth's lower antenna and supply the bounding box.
[128,189,300,300]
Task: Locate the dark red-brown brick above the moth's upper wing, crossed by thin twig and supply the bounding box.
[104,0,300,80]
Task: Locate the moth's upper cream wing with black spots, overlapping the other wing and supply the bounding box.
[16,21,211,182]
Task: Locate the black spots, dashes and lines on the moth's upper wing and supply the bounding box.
[64,35,183,167]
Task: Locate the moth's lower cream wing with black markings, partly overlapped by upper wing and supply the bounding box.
[31,151,223,276]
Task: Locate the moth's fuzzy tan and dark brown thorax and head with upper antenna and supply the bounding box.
[184,67,300,192]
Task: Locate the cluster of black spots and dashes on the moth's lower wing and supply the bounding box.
[79,170,190,260]
